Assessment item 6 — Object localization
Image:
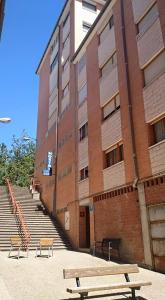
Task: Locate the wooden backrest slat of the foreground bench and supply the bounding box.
[63,264,139,279]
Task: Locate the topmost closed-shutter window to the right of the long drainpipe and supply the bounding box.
[137,4,159,34]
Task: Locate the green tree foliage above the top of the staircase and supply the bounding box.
[0,136,35,186]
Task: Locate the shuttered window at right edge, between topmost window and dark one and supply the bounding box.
[144,51,165,85]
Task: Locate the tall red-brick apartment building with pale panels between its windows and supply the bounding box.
[35,0,165,272]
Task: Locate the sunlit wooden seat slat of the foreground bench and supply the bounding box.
[67,281,152,294]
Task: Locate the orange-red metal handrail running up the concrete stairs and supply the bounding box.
[6,179,31,250]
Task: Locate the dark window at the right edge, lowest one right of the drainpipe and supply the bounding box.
[152,118,165,144]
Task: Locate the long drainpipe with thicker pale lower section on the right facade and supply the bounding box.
[120,0,153,266]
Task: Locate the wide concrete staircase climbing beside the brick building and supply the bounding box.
[0,187,71,250]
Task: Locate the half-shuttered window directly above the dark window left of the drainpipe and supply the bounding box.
[102,94,120,120]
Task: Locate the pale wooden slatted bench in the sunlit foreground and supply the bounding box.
[63,265,152,300]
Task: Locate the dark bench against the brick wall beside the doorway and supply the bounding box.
[93,238,121,260]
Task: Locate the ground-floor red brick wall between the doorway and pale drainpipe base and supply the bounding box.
[94,192,144,263]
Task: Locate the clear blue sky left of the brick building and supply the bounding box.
[0,0,65,148]
